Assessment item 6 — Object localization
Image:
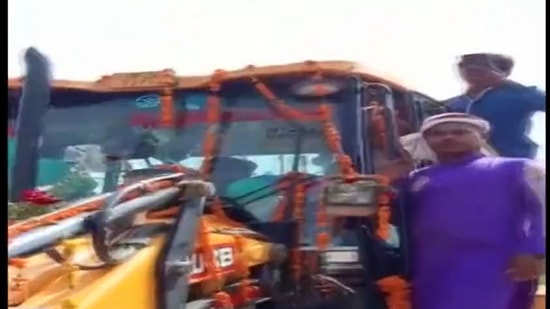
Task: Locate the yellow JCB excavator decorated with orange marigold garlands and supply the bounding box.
[8,49,445,309]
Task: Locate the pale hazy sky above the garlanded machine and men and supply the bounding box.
[8,0,546,156]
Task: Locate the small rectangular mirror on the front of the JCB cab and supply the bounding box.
[323,177,386,217]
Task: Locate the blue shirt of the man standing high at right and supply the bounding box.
[447,82,546,159]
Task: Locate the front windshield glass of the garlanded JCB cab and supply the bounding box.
[12,78,358,244]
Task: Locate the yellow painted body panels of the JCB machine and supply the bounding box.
[8,215,271,309]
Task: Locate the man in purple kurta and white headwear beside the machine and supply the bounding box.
[409,113,546,309]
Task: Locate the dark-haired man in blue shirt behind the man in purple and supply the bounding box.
[447,53,546,159]
